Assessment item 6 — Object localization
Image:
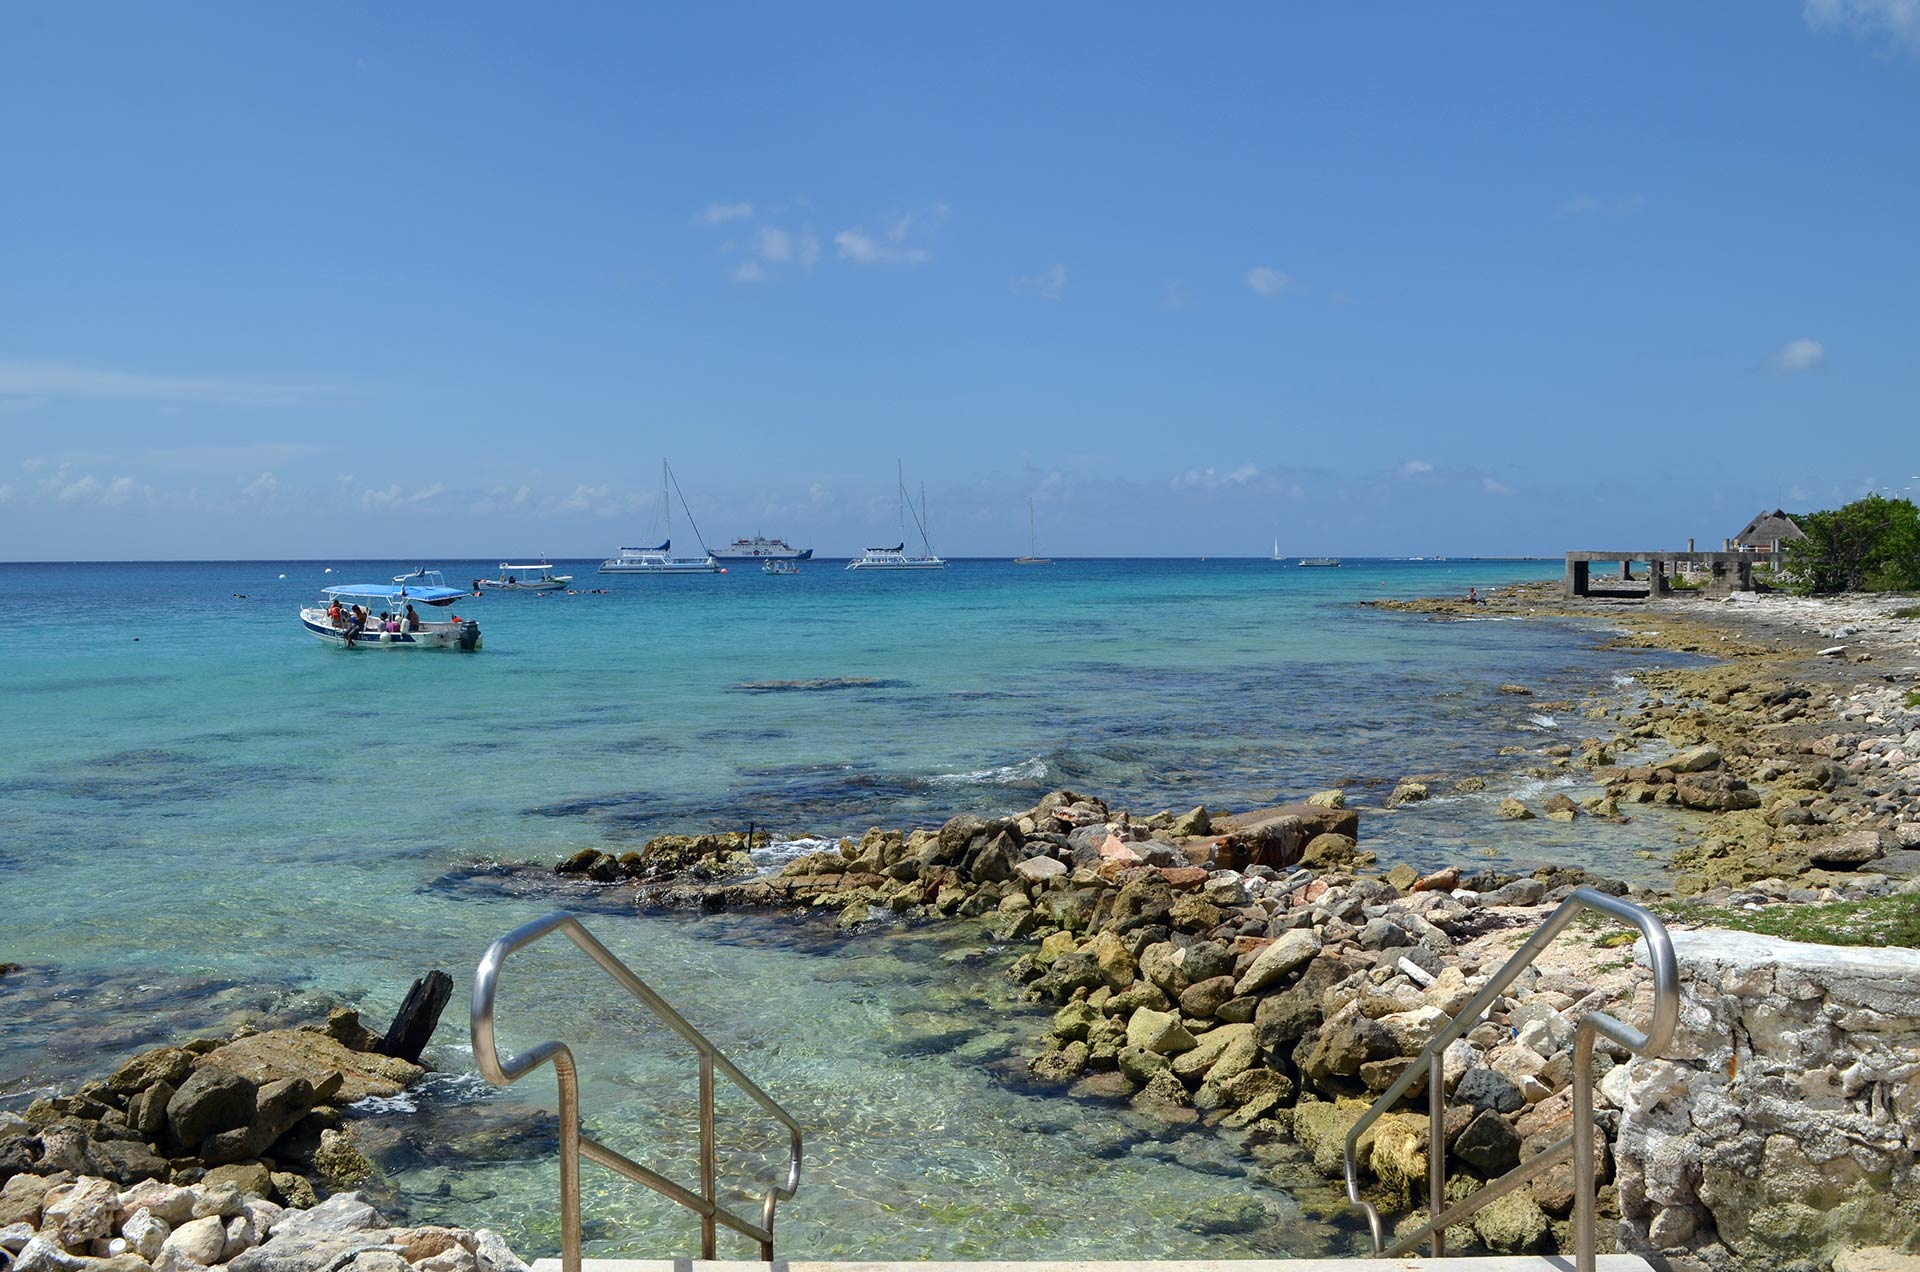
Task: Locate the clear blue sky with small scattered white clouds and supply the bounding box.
[0,0,1920,561]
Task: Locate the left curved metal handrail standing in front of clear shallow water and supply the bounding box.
[472,913,801,1272]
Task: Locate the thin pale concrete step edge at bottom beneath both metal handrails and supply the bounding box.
[534,1255,1653,1272]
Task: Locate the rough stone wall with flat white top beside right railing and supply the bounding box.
[1599,932,1920,1272]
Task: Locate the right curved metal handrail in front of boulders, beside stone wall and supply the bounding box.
[1346,888,1680,1272]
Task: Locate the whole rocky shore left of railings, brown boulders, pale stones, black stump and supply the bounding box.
[0,999,541,1272]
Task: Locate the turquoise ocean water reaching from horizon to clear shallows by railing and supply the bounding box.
[0,559,1678,1259]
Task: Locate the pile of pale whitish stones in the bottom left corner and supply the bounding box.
[0,1174,526,1272]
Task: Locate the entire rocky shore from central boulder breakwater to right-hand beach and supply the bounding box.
[557,586,1920,1268]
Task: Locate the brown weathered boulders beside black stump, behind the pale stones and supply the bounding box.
[0,1011,426,1224]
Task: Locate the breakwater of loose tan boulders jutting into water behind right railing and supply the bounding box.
[587,792,1666,1253]
